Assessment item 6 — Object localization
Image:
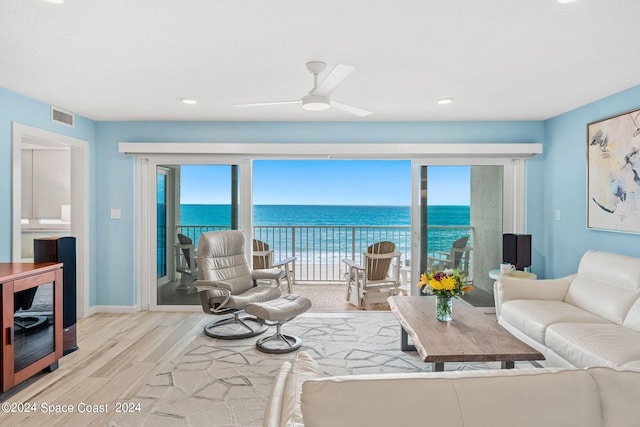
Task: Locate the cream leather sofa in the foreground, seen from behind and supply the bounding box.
[263,352,640,427]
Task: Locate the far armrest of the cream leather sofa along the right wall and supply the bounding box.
[493,274,576,319]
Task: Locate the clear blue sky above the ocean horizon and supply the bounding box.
[180,160,469,206]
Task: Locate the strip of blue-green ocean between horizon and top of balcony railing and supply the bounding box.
[180,205,469,226]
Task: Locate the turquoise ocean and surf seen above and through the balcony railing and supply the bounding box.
[164,204,470,280]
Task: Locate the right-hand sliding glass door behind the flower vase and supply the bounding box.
[413,161,514,307]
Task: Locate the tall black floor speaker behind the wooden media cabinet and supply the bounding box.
[33,237,78,355]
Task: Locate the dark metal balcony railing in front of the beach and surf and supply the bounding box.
[176,225,472,282]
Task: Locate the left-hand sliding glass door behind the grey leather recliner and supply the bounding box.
[152,164,239,306]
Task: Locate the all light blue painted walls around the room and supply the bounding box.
[0,86,640,306]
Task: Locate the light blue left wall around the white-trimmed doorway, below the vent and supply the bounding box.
[0,87,95,306]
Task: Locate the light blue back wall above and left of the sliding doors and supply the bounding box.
[96,122,544,305]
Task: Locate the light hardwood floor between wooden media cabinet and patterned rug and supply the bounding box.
[0,312,211,427]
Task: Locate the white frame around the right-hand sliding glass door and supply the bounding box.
[410,156,525,295]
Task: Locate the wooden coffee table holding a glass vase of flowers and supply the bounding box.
[388,296,544,371]
